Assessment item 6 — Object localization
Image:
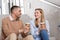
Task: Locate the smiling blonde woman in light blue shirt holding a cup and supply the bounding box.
[30,8,49,40]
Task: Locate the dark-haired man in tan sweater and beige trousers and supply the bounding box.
[2,6,33,40]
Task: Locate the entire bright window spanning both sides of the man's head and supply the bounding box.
[2,0,24,15]
